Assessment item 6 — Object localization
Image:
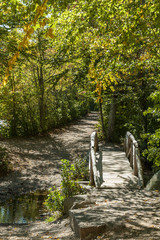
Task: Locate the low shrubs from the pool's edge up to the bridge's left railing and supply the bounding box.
[44,159,88,222]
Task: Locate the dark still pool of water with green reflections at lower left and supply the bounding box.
[0,191,47,224]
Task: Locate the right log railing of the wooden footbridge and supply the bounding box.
[124,132,144,188]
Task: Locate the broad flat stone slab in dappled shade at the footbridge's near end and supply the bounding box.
[69,189,160,240]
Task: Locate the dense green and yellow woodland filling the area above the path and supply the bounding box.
[0,0,160,170]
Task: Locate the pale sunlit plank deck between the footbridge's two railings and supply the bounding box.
[101,146,138,188]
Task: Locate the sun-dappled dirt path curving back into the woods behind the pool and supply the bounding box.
[0,112,98,202]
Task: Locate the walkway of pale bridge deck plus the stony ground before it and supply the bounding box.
[69,145,160,240]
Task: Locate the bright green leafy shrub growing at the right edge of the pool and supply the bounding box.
[45,159,83,220]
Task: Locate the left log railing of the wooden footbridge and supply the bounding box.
[89,132,103,188]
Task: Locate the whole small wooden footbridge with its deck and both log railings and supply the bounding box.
[90,132,144,188]
